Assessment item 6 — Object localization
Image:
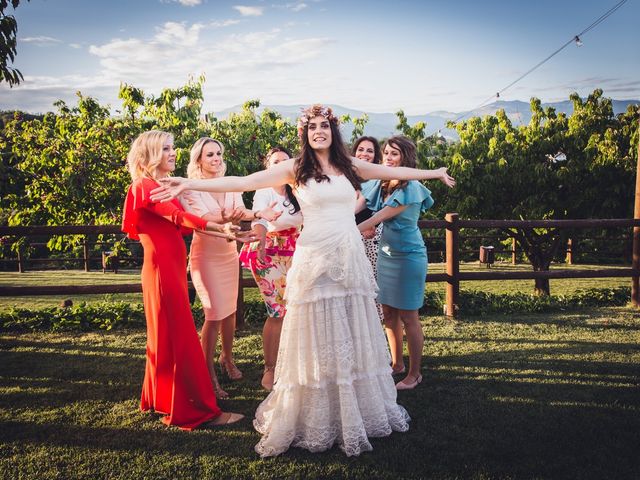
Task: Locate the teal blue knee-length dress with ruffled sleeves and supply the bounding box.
[365,180,433,310]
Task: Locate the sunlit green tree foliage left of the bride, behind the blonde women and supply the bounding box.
[0,77,297,253]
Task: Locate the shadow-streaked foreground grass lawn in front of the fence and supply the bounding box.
[0,308,640,479]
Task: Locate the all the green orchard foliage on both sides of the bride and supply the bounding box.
[0,82,639,293]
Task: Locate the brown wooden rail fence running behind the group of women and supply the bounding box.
[0,218,640,324]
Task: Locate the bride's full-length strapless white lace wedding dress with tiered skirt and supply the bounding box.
[253,176,409,457]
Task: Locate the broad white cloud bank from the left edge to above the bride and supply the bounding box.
[0,22,334,111]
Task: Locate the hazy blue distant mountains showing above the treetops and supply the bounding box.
[215,100,640,139]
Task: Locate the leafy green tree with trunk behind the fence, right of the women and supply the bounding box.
[447,90,638,294]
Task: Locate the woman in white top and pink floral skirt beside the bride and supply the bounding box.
[240,147,302,391]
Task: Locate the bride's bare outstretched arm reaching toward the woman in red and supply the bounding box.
[151,160,294,202]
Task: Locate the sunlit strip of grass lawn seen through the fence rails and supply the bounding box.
[0,262,631,311]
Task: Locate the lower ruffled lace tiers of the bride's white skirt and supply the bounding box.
[254,288,409,457]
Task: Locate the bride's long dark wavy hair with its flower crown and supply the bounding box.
[294,105,362,190]
